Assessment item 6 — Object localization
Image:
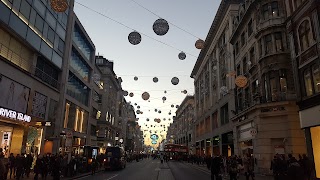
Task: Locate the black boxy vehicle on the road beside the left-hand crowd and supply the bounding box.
[104,147,127,170]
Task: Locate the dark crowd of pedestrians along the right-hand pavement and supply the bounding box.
[187,154,314,180]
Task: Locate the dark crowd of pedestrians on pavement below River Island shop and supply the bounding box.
[0,148,104,180]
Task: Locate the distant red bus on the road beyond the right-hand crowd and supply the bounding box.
[164,144,189,161]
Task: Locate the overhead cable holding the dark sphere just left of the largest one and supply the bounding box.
[76,2,197,58]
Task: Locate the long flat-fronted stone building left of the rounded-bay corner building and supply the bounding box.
[191,0,239,156]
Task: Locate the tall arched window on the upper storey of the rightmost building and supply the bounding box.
[298,20,313,51]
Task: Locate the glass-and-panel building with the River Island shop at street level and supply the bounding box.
[0,0,73,156]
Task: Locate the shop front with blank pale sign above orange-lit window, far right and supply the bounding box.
[299,106,320,179]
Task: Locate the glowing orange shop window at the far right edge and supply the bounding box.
[310,126,320,178]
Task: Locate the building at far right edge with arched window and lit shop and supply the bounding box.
[286,0,320,179]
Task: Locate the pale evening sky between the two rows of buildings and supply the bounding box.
[75,0,221,145]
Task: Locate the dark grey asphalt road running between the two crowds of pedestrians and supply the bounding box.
[6,158,273,180]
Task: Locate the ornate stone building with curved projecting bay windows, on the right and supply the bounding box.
[230,0,306,173]
